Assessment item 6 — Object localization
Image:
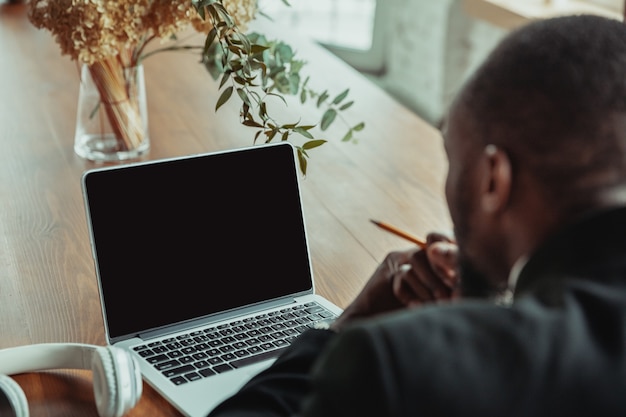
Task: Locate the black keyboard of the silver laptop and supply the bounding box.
[133,302,335,385]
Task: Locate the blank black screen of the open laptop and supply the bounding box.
[83,143,313,339]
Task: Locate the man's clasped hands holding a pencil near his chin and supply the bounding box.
[331,233,458,330]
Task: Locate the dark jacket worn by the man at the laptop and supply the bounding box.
[211,208,626,417]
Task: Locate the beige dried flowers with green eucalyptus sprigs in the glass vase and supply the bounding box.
[29,0,364,173]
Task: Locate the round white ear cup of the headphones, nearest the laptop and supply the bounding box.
[92,346,143,417]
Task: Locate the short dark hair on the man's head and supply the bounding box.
[459,15,626,211]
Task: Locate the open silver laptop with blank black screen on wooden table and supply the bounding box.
[82,142,341,417]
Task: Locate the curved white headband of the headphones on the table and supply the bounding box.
[0,343,96,375]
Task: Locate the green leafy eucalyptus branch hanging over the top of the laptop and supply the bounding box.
[194,0,365,174]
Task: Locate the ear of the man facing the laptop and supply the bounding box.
[481,145,513,213]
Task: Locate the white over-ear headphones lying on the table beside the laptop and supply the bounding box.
[0,343,143,417]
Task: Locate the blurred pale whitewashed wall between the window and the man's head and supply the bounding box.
[370,0,506,125]
